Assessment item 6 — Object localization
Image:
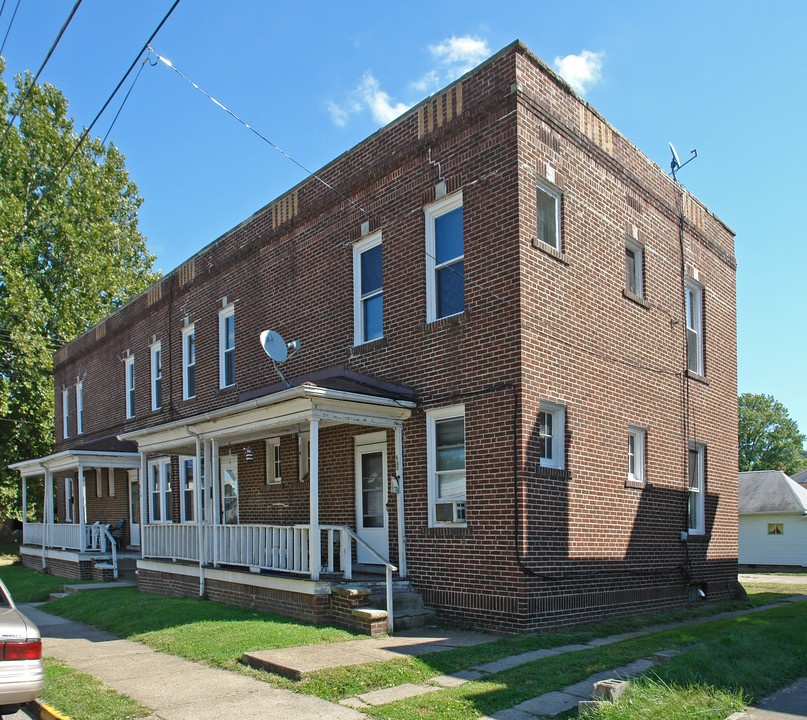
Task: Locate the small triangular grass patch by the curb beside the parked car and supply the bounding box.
[41,658,152,720]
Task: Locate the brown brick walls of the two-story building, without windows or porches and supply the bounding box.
[45,45,737,631]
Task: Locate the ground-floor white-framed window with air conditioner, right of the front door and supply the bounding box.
[426,405,465,527]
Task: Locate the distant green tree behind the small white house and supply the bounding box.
[738,393,807,475]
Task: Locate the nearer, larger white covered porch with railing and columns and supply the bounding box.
[119,369,414,632]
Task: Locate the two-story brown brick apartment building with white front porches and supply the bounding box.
[15,42,737,632]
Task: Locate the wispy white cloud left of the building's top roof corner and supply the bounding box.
[328,35,490,127]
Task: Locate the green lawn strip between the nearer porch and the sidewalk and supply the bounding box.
[42,588,356,669]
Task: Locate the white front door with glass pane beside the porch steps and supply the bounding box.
[356,436,389,565]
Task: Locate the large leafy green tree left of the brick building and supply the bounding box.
[0,58,158,519]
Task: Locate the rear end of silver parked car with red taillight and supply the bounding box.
[0,580,45,716]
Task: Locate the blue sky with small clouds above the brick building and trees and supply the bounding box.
[0,0,807,432]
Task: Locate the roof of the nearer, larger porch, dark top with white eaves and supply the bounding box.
[118,368,416,452]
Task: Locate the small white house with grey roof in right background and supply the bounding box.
[738,470,807,567]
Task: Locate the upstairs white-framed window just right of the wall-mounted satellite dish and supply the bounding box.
[353,232,384,345]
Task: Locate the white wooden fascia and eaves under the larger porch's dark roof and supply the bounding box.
[118,385,415,453]
